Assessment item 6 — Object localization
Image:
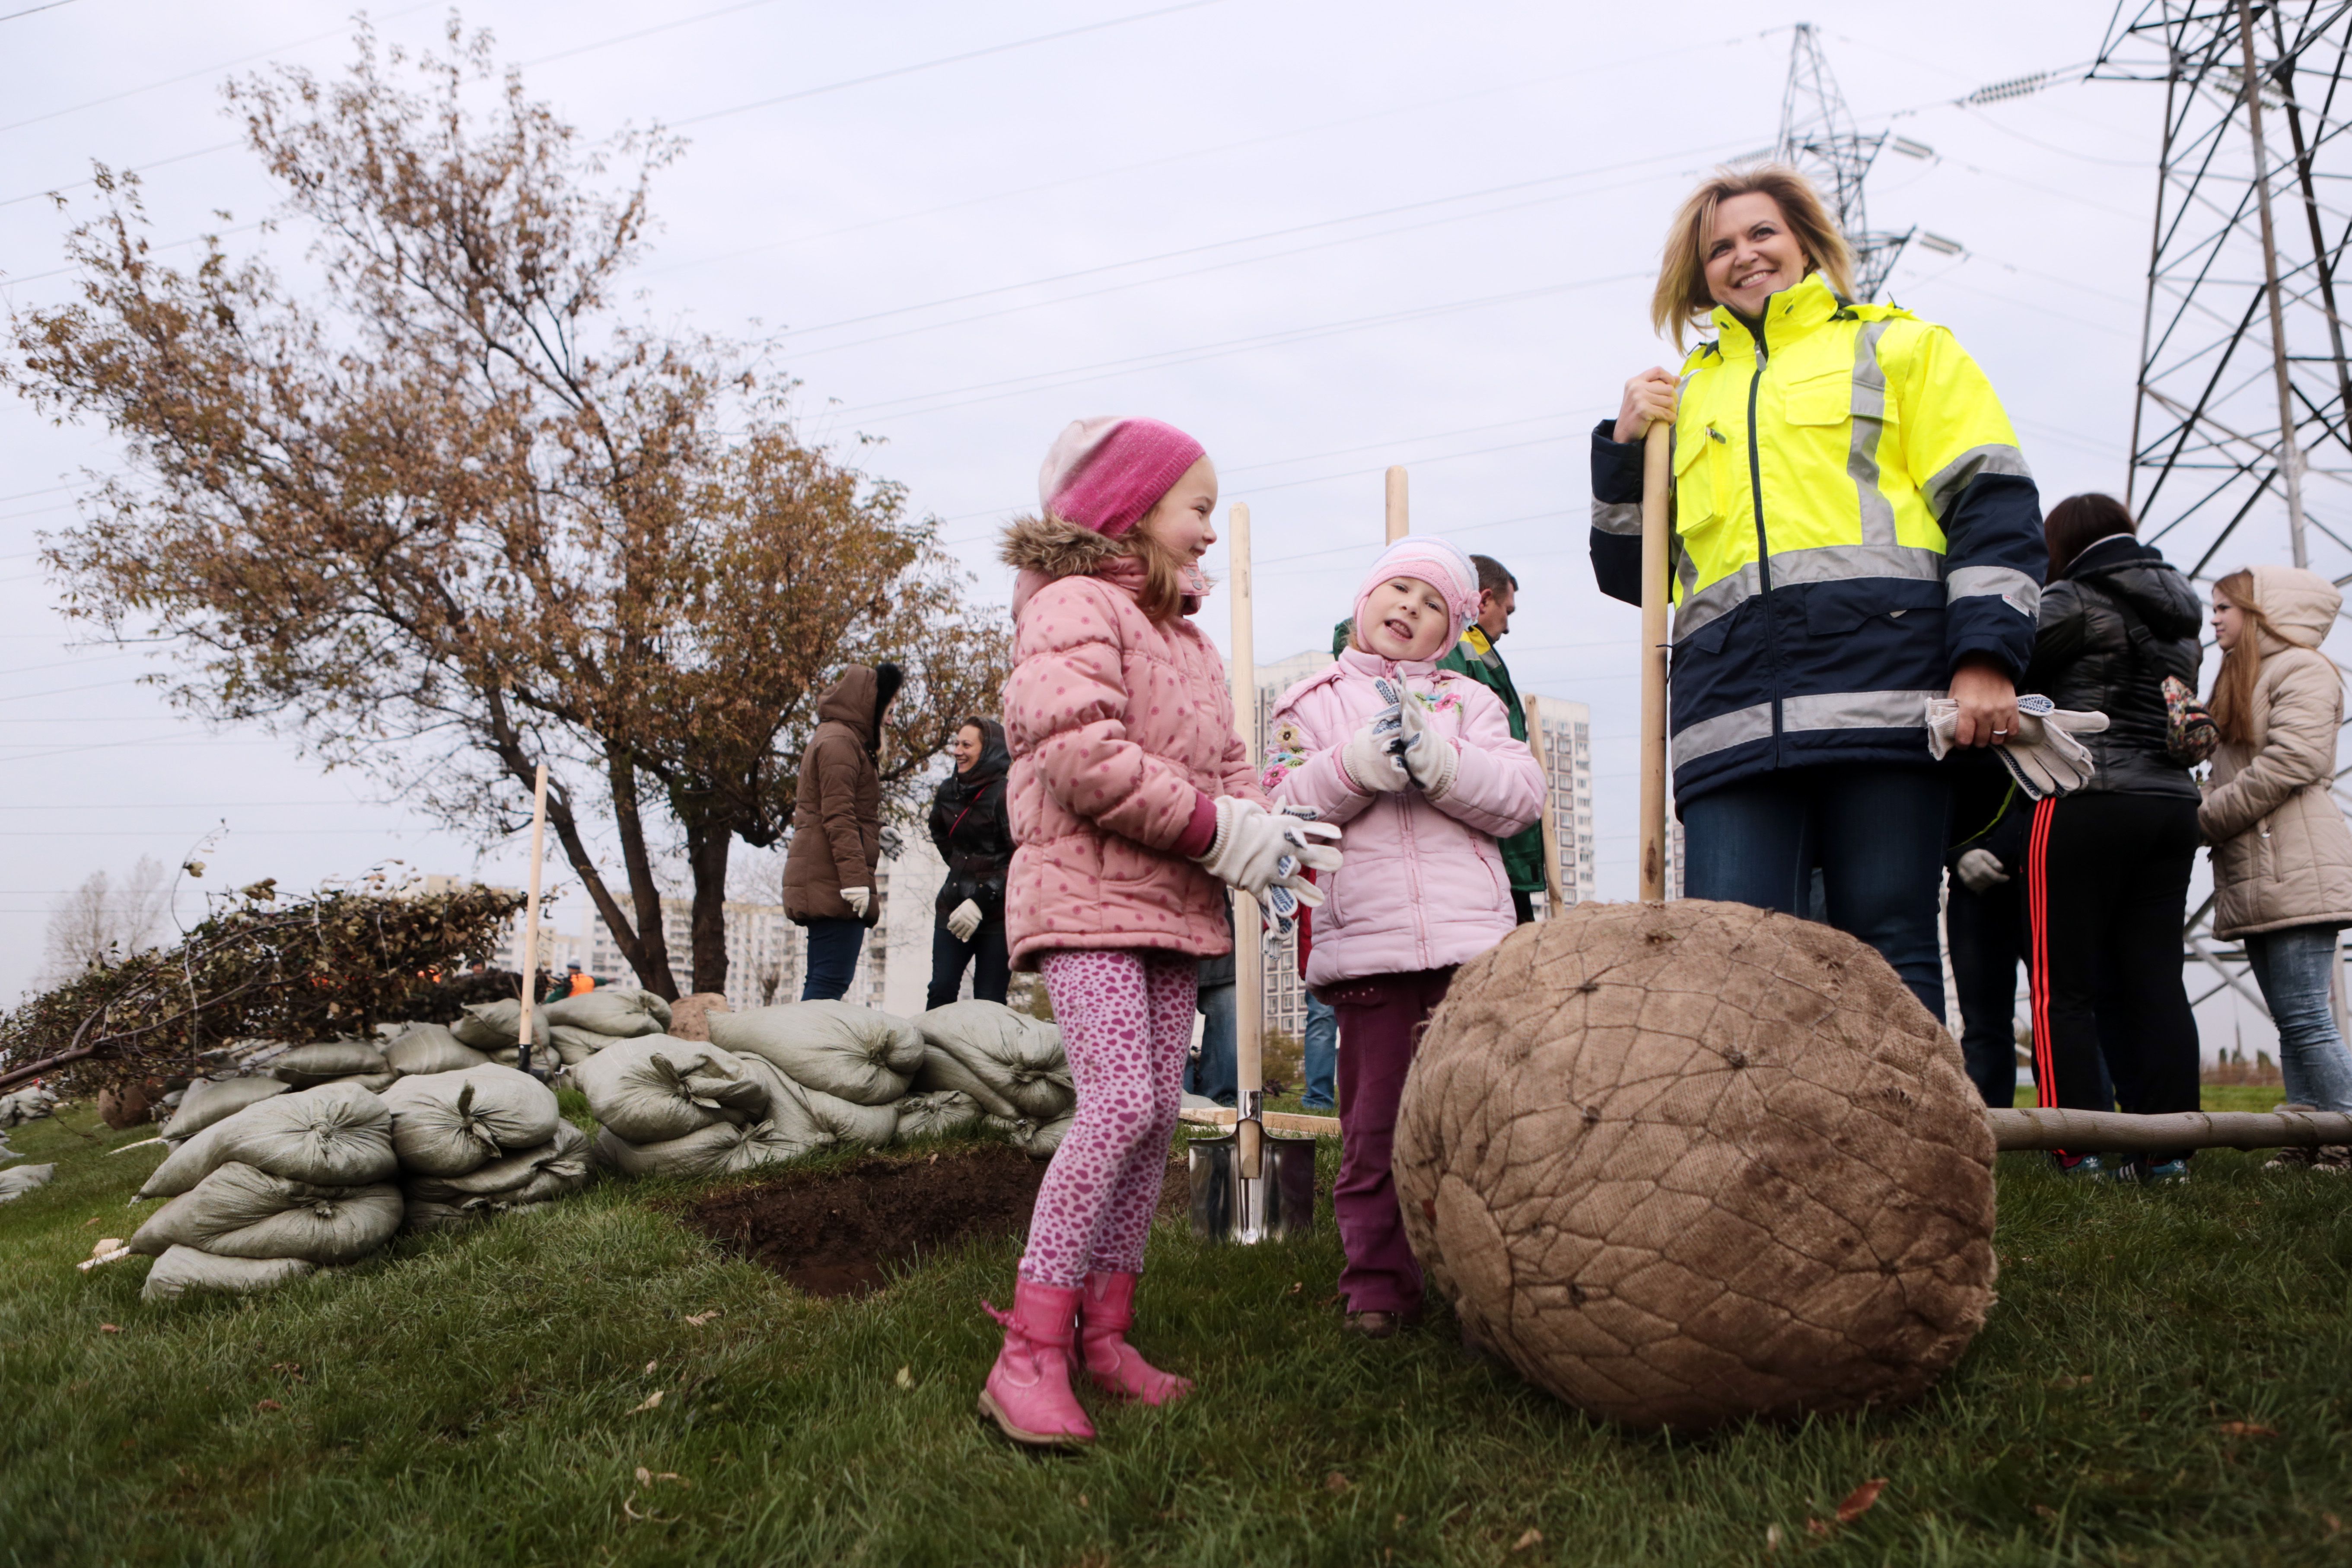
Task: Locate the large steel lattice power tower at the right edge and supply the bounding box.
[2091,0,2352,1043]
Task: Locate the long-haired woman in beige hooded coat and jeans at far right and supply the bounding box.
[2197,566,2352,1133]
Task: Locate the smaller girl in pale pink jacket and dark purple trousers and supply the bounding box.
[1265,538,1543,1338]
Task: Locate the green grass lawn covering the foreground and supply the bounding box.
[0,1112,2352,1568]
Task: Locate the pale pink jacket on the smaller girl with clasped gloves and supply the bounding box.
[1265,649,1543,985]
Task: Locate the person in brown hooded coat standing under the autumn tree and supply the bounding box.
[783,663,901,1002]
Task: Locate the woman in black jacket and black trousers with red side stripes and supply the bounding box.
[2025,496,2204,1180]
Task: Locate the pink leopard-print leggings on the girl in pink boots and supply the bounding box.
[1021,952,1197,1291]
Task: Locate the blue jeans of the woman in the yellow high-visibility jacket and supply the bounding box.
[1682,764,1952,1023]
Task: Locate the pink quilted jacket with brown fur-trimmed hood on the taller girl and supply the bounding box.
[1004,519,1265,969]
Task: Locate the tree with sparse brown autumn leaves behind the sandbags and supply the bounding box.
[5,19,1007,994]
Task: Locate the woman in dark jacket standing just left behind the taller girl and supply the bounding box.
[924,715,1014,1006]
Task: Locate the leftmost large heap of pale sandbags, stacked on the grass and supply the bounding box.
[129,1062,588,1300]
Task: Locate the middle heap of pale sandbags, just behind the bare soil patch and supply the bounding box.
[572,1002,922,1175]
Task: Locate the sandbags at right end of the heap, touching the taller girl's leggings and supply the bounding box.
[898,1002,1077,1159]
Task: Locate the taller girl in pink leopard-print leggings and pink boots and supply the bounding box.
[981,418,1338,1446]
